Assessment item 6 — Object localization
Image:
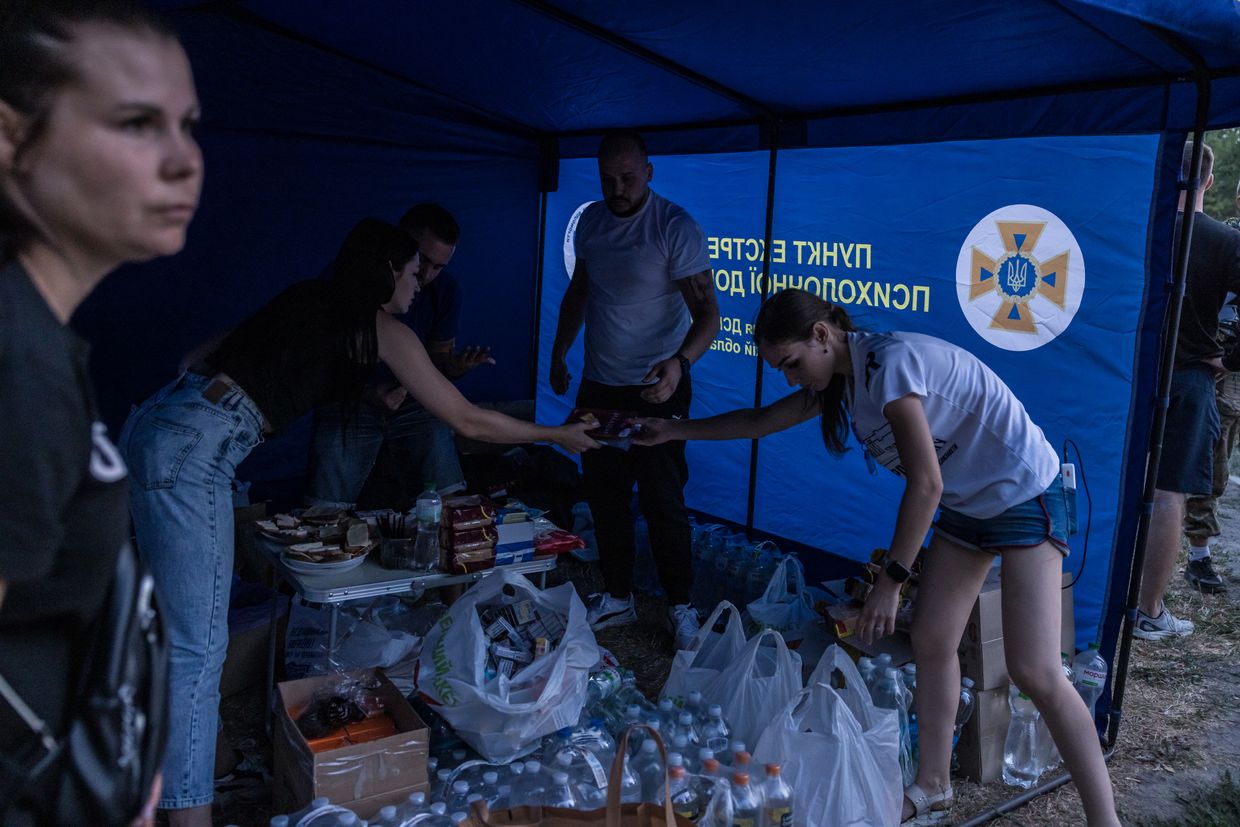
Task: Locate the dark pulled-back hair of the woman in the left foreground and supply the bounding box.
[0,0,176,262]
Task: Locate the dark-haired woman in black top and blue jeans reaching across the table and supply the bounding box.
[120,218,595,825]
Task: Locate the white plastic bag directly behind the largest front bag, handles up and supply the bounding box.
[702,629,801,745]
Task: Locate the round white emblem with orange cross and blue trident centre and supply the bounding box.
[956,203,1085,351]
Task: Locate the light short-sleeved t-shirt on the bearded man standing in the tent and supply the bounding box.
[573,190,711,386]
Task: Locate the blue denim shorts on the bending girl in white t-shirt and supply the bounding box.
[934,474,1069,557]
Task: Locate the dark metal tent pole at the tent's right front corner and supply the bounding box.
[1104,30,1210,749]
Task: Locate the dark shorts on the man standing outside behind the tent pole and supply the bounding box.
[1157,362,1219,495]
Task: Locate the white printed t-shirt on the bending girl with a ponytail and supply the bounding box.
[848,332,1059,520]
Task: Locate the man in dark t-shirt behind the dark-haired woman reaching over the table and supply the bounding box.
[306,203,495,506]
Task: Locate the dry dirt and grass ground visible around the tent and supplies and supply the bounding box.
[216,486,1240,827]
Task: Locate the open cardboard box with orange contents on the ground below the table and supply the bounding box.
[272,670,430,812]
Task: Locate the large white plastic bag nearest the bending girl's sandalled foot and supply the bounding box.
[754,646,904,827]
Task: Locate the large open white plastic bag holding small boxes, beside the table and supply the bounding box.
[414,569,599,764]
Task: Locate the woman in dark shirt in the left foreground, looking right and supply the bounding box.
[0,0,202,825]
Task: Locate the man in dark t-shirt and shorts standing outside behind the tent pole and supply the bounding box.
[1133,141,1240,640]
